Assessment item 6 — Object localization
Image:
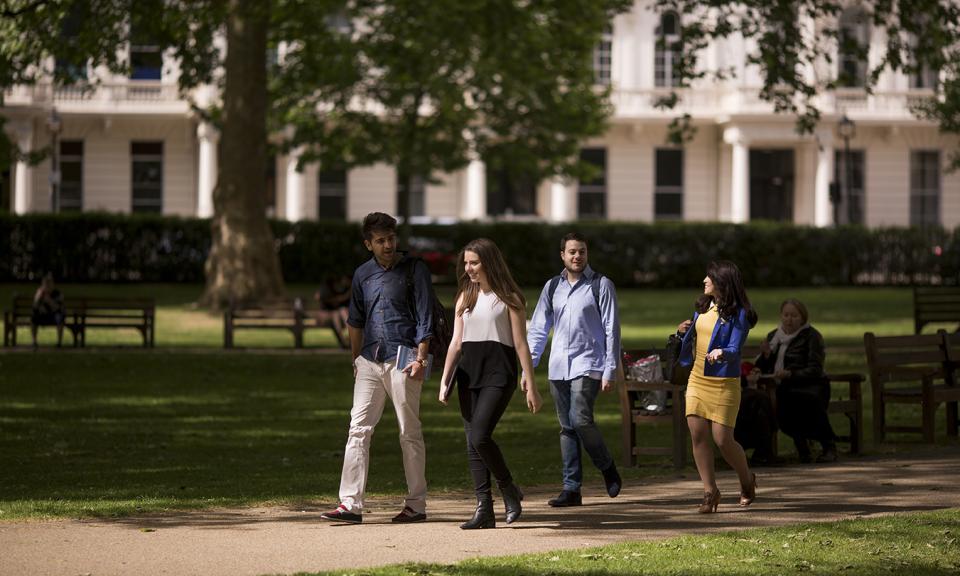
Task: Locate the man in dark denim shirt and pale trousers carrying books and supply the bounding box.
[321,212,433,524]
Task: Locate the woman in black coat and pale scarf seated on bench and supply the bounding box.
[756,298,837,462]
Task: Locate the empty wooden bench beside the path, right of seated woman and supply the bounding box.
[863,331,960,443]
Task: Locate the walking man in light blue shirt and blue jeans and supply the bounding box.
[521,232,622,507]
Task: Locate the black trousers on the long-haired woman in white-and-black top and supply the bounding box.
[457,384,517,498]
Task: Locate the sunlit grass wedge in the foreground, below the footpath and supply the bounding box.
[308,509,960,576]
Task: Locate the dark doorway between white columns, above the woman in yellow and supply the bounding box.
[750,150,794,222]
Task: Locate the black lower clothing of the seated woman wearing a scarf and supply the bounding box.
[777,379,837,446]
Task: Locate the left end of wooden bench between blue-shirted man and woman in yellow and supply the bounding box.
[617,350,687,469]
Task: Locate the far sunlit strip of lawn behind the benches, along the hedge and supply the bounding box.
[0,284,936,348]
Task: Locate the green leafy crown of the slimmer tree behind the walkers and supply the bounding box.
[273,0,632,228]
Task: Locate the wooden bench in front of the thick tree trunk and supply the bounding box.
[223,298,349,348]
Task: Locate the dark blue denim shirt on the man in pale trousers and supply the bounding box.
[347,254,433,362]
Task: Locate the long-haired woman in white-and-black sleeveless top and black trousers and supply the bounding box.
[440,238,543,530]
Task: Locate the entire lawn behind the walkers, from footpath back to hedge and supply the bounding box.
[0,285,956,520]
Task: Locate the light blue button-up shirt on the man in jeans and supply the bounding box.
[527,266,620,380]
